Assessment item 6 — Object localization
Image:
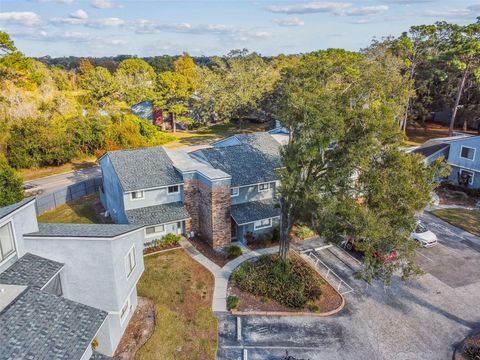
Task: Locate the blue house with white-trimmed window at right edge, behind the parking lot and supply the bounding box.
[412,133,480,189]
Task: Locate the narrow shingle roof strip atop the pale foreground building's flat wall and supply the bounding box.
[25,224,141,238]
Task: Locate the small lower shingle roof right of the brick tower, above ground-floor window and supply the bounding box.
[231,200,280,225]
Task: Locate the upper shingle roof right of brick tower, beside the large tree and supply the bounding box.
[193,133,282,187]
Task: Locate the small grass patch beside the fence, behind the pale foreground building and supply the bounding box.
[38,193,106,224]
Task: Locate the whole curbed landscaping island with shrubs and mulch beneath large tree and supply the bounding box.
[228,254,343,314]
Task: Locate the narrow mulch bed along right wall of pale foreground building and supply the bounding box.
[115,297,155,360]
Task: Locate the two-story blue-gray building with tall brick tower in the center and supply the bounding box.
[100,133,284,247]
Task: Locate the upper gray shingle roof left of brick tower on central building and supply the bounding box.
[108,147,183,191]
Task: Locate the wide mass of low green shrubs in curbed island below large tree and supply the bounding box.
[232,255,322,308]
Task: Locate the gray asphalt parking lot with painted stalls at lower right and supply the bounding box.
[217,214,480,360]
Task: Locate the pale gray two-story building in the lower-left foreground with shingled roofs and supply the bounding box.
[0,199,144,360]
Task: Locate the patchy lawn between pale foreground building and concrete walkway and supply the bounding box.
[135,250,218,360]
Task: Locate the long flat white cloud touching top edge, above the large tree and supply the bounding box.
[267,2,388,16]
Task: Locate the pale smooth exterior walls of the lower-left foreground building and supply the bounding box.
[25,229,144,355]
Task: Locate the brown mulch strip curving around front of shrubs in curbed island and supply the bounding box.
[227,257,342,314]
